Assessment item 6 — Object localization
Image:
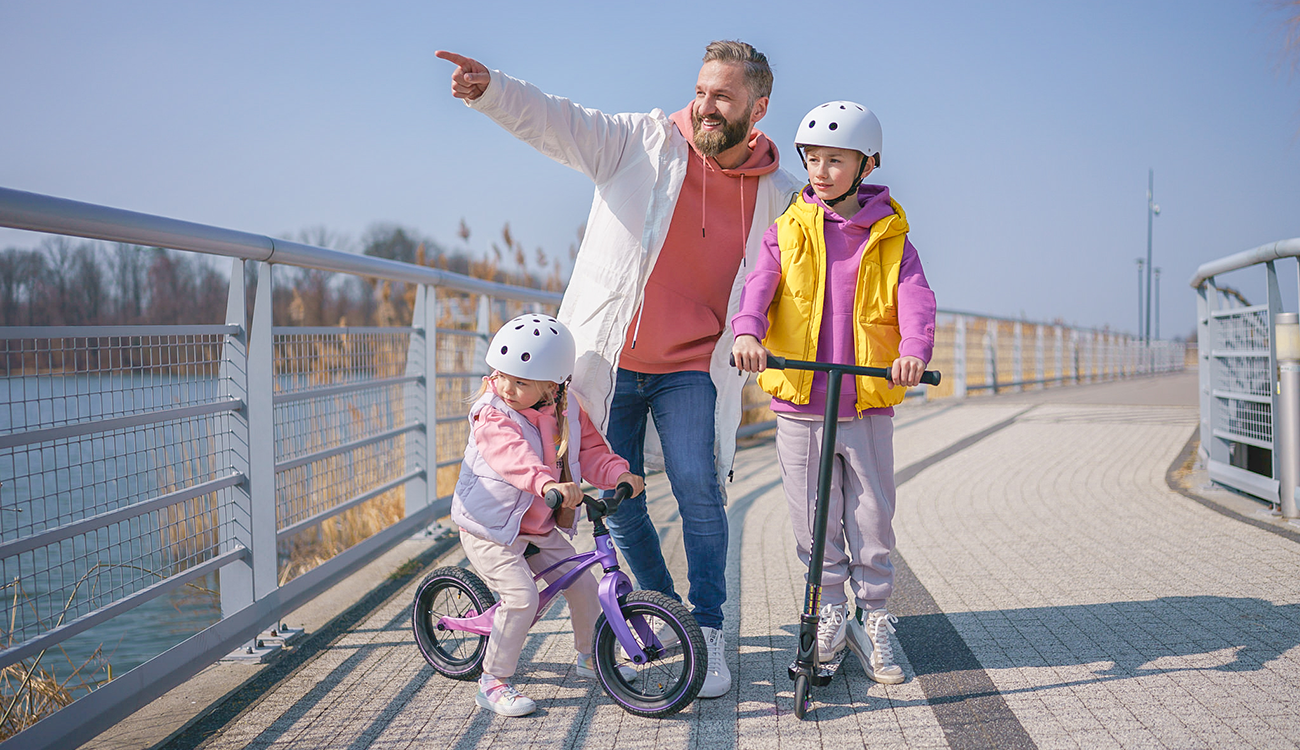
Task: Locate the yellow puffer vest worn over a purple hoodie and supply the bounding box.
[758,187,907,413]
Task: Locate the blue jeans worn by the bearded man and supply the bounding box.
[606,368,727,628]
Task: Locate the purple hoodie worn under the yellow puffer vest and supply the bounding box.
[732,185,936,419]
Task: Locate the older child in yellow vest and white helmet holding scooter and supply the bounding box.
[732,101,935,684]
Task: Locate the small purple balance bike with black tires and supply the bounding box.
[411,484,709,718]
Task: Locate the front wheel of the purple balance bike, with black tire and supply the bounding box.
[594,591,709,718]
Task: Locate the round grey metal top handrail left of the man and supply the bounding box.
[0,187,562,304]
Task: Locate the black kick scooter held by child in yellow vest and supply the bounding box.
[732,354,941,719]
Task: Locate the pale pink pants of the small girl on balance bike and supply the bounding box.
[460,529,601,680]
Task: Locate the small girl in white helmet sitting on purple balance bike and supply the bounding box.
[451,315,644,716]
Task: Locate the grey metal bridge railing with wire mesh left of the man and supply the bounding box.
[0,188,560,749]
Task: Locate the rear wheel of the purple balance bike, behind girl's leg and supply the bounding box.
[411,567,494,680]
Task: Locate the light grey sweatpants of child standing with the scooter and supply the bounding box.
[776,415,894,614]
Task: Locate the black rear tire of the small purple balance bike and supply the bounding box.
[411,565,495,680]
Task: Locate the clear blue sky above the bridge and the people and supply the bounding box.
[0,0,1300,335]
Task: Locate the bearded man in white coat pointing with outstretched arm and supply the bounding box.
[437,42,801,698]
